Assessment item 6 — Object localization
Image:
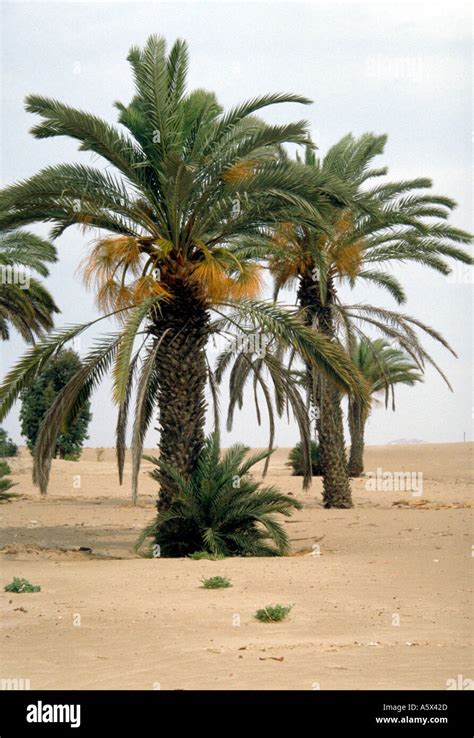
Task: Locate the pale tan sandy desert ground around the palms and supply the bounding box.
[0,443,474,689]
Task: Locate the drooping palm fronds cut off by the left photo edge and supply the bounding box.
[0,231,59,343]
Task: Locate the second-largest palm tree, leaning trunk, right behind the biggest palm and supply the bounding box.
[271,133,472,507]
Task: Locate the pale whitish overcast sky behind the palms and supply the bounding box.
[0,0,473,446]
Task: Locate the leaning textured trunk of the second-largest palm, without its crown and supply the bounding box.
[298,273,352,508]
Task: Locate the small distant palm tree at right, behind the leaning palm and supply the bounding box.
[348,338,423,477]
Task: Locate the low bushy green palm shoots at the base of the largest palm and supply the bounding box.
[137,434,302,557]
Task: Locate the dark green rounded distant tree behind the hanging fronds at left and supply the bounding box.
[20,349,92,460]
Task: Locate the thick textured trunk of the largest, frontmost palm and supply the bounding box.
[153,283,209,512]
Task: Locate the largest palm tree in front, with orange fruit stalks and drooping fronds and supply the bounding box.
[0,36,361,511]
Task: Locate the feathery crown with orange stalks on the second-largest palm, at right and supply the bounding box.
[272,133,472,303]
